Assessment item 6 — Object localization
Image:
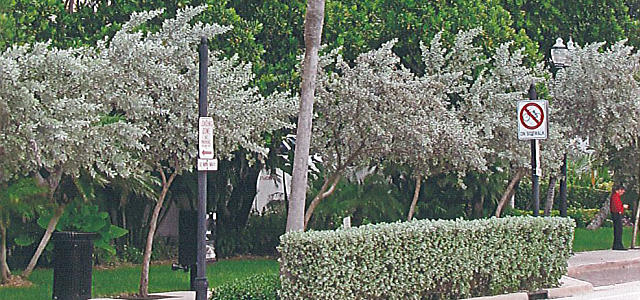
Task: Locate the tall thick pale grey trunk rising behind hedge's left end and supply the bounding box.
[286,0,325,232]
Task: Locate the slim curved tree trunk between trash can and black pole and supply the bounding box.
[138,170,177,297]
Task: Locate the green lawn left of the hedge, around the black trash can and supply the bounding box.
[0,259,278,300]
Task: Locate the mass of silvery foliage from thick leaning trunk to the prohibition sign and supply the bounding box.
[314,29,565,183]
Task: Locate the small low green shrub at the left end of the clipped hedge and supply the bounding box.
[211,273,280,300]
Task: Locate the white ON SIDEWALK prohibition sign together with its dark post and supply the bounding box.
[518,84,549,217]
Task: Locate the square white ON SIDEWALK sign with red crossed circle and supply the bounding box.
[518,100,549,140]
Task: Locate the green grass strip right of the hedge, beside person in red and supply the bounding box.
[573,227,633,252]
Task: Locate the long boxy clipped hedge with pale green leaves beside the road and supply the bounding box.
[278,217,575,299]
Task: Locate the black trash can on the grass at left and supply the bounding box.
[52,231,98,300]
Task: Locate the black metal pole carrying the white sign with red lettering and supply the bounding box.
[192,37,209,300]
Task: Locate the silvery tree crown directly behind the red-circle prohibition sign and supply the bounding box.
[444,29,564,172]
